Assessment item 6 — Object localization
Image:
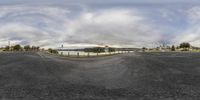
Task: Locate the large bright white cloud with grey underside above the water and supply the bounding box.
[66,9,161,46]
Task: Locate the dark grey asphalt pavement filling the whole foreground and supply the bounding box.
[0,53,200,100]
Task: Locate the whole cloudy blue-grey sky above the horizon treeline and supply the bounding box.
[0,0,200,48]
